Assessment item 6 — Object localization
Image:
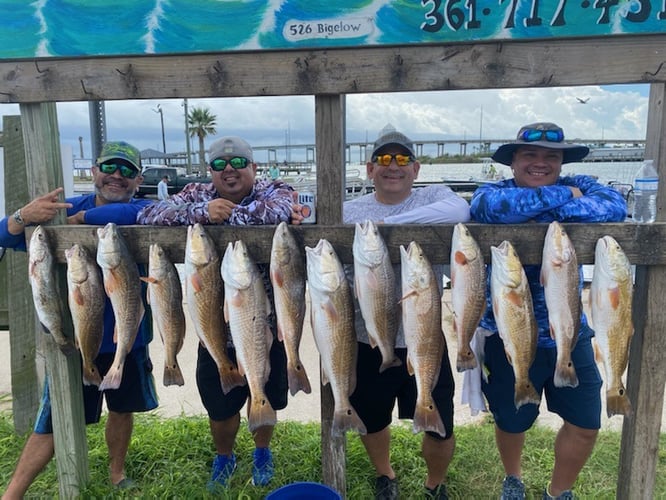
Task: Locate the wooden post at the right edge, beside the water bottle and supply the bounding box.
[617,83,666,500]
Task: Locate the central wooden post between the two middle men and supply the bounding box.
[315,95,347,497]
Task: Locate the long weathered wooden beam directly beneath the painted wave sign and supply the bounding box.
[0,35,666,102]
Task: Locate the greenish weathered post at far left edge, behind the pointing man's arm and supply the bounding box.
[2,116,39,434]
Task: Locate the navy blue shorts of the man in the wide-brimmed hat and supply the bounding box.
[481,334,602,433]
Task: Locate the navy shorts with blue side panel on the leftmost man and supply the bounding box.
[34,346,157,434]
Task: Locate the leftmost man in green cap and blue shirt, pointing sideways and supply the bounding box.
[0,141,157,500]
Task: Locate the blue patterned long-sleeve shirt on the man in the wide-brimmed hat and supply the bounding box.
[470,175,627,348]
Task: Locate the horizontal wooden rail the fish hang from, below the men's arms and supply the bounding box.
[35,223,666,265]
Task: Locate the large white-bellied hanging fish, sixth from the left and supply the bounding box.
[221,240,277,432]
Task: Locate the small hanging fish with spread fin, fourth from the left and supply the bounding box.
[141,243,185,386]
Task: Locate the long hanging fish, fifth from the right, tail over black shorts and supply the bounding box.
[400,241,446,437]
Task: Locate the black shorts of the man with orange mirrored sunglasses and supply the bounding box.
[350,342,455,439]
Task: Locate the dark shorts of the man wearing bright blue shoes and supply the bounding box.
[192,338,288,421]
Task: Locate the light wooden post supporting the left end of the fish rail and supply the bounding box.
[21,103,88,498]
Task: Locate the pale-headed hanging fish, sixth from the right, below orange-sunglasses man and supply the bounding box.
[352,220,402,373]
